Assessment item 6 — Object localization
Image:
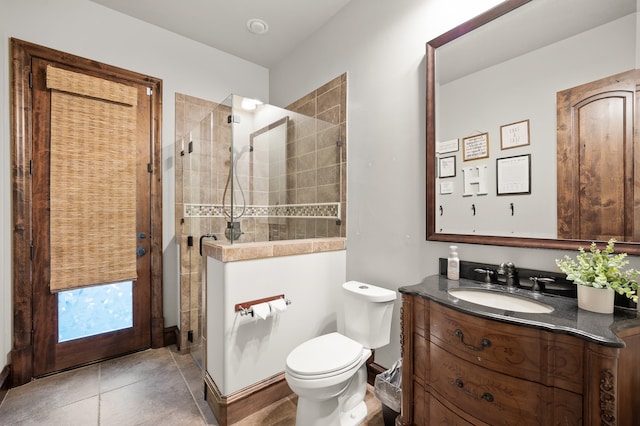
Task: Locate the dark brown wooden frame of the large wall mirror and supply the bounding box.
[426,0,640,255]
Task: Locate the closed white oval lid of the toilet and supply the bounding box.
[287,333,362,376]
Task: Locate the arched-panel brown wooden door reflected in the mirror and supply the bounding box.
[557,70,640,241]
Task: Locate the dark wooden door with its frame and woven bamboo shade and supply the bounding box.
[12,40,164,385]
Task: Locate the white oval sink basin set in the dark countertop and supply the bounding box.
[449,288,553,314]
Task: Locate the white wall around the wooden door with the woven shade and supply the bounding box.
[0,0,269,370]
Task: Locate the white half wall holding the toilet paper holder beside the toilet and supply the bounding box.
[206,250,346,395]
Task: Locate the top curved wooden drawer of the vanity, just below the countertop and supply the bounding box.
[430,303,547,382]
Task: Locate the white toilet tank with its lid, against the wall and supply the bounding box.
[342,281,396,349]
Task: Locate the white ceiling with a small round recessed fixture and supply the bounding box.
[91,0,350,68]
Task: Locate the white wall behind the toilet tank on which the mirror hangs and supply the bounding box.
[270,0,637,367]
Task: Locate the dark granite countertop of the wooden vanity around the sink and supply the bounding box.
[398,275,640,347]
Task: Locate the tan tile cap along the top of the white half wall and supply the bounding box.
[202,237,347,262]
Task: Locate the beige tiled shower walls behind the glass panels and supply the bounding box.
[175,74,347,356]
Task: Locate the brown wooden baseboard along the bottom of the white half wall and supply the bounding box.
[204,373,293,426]
